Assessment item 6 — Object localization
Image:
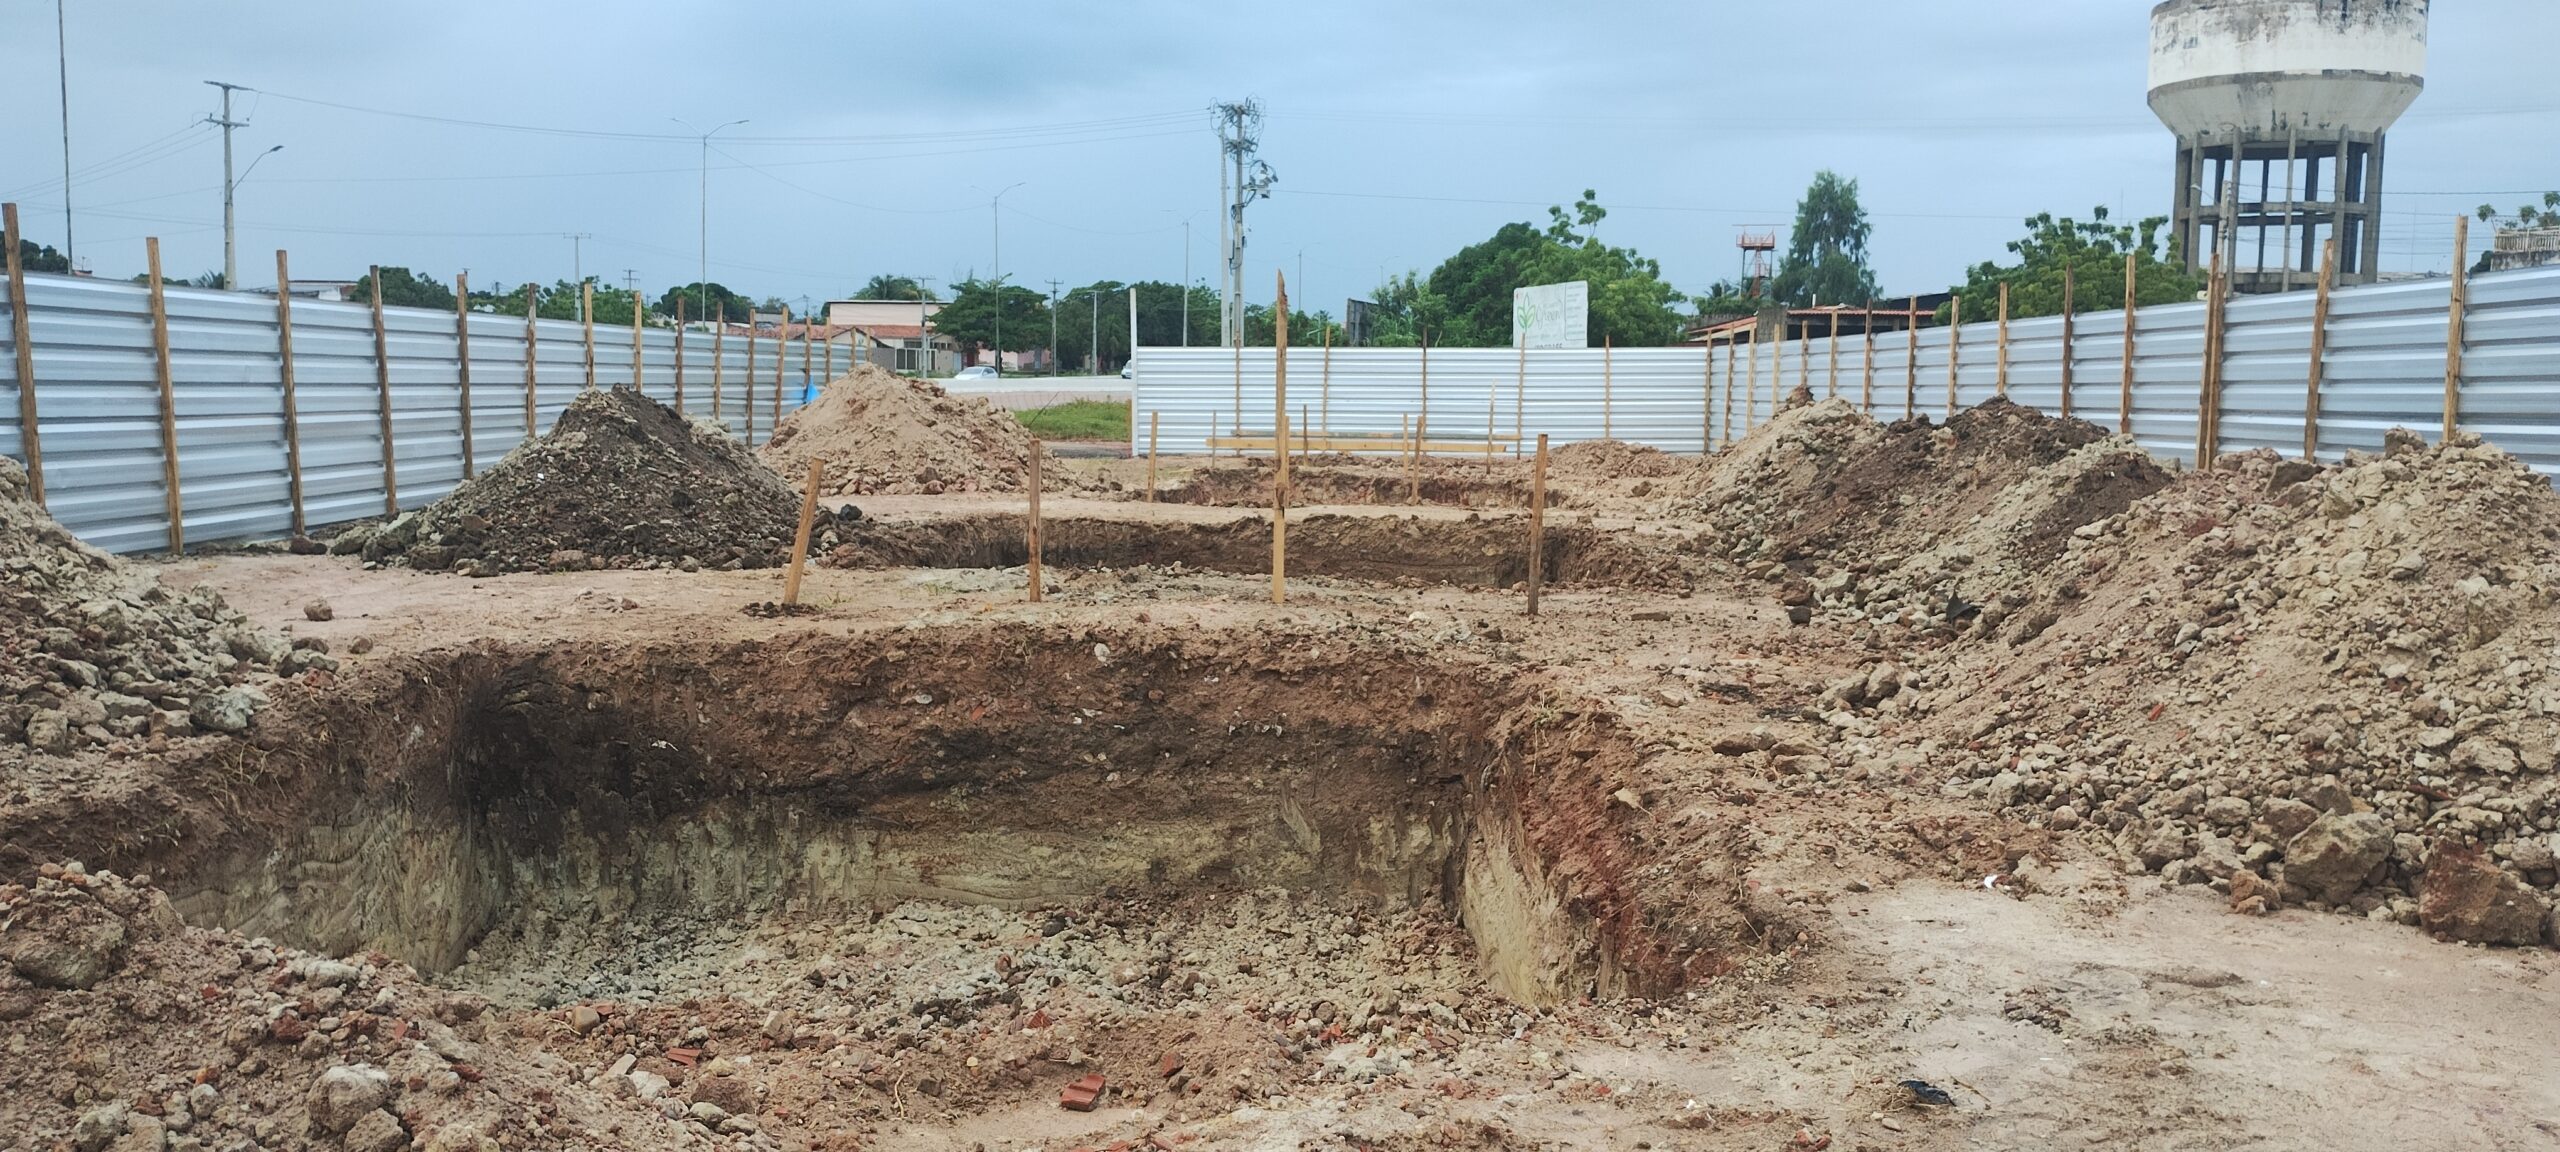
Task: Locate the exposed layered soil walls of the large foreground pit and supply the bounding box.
[145,627,1708,1004]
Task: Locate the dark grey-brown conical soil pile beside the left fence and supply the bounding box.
[330,387,835,576]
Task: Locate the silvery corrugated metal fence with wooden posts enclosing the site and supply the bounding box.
[15,269,2560,553]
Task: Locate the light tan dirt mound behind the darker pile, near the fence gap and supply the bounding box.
[758,364,1065,497]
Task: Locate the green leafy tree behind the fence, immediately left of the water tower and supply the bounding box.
[1938,205,2204,320]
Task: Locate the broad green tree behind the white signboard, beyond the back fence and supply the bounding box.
[1372,189,1684,348]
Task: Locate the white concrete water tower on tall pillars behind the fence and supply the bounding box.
[2150,0,2427,292]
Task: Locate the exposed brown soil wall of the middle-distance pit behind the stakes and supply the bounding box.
[827,515,1697,591]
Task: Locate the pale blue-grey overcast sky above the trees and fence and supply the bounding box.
[0,0,2560,312]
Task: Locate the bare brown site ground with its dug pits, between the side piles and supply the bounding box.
[0,422,2560,1152]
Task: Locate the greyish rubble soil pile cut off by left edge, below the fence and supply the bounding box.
[0,458,304,755]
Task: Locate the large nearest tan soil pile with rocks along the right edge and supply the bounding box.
[1825,433,2560,945]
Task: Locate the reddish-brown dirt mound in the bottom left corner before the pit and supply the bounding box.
[0,865,707,1152]
